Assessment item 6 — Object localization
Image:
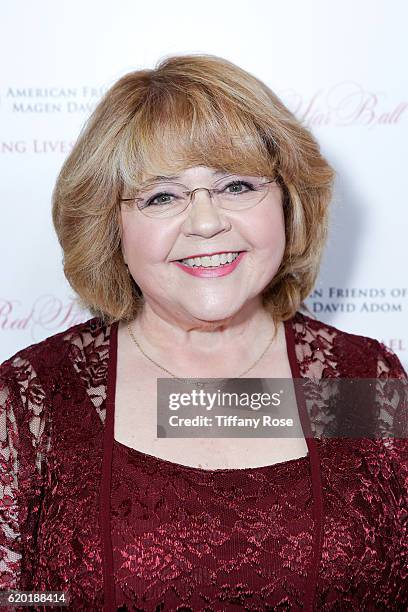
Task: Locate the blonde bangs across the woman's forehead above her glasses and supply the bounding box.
[119,83,277,190]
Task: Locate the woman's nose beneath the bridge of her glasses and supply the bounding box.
[183,187,230,237]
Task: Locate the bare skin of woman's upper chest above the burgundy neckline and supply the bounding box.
[114,346,308,469]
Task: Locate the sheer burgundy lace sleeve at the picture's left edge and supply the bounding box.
[0,354,46,611]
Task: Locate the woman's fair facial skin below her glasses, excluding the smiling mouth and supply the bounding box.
[120,166,285,322]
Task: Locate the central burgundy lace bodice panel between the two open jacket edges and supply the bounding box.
[112,444,314,610]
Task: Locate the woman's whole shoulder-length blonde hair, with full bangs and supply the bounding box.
[52,54,334,323]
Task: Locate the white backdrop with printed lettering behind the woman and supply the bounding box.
[0,0,408,367]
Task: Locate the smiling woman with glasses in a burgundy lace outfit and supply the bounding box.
[0,55,408,611]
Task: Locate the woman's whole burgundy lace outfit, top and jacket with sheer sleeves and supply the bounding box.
[0,312,408,612]
